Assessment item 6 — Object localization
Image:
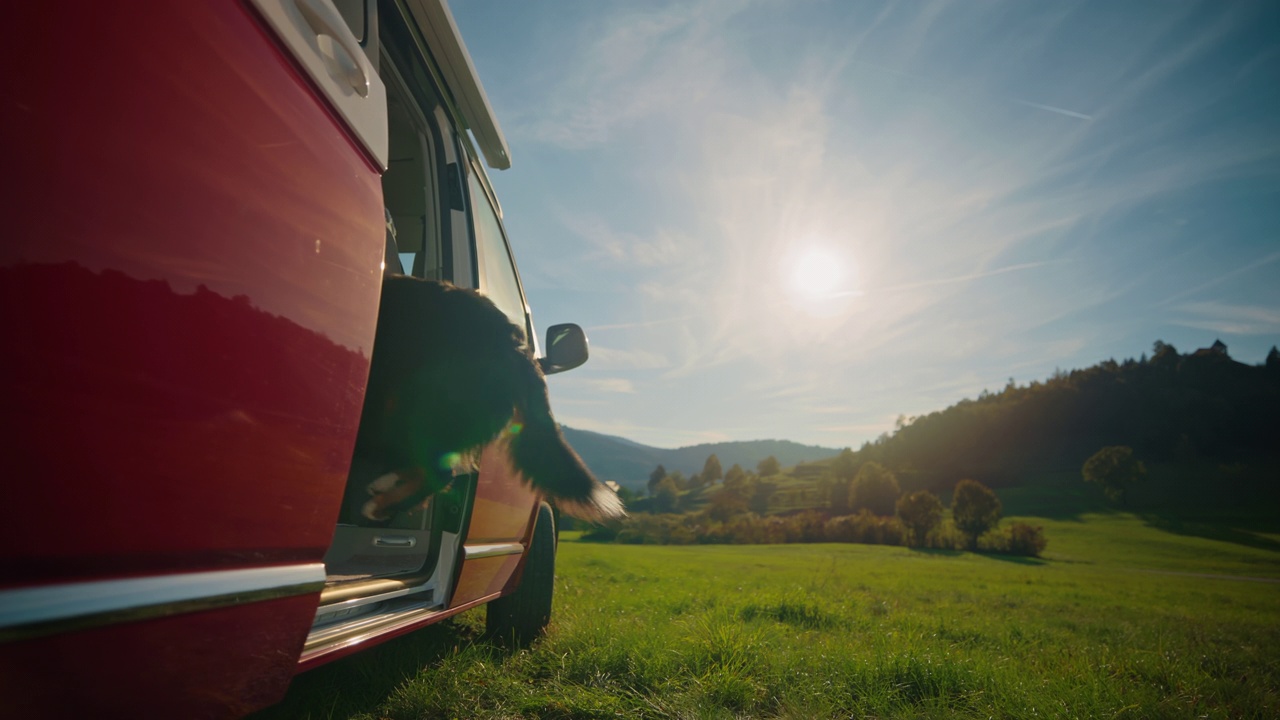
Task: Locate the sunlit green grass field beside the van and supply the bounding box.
[252,497,1280,719]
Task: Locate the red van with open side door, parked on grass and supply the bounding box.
[0,0,586,717]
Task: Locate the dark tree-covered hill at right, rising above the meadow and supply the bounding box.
[855,341,1280,489]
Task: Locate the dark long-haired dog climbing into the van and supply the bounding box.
[356,275,626,521]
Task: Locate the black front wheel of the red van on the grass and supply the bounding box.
[485,502,556,644]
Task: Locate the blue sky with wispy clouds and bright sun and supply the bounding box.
[452,0,1280,447]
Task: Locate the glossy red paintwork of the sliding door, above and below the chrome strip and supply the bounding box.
[0,0,384,717]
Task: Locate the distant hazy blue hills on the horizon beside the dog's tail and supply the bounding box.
[561,427,840,489]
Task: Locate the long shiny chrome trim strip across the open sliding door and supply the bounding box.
[0,562,324,642]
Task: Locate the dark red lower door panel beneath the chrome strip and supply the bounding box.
[0,596,315,720]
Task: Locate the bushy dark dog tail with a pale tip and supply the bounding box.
[512,356,626,523]
